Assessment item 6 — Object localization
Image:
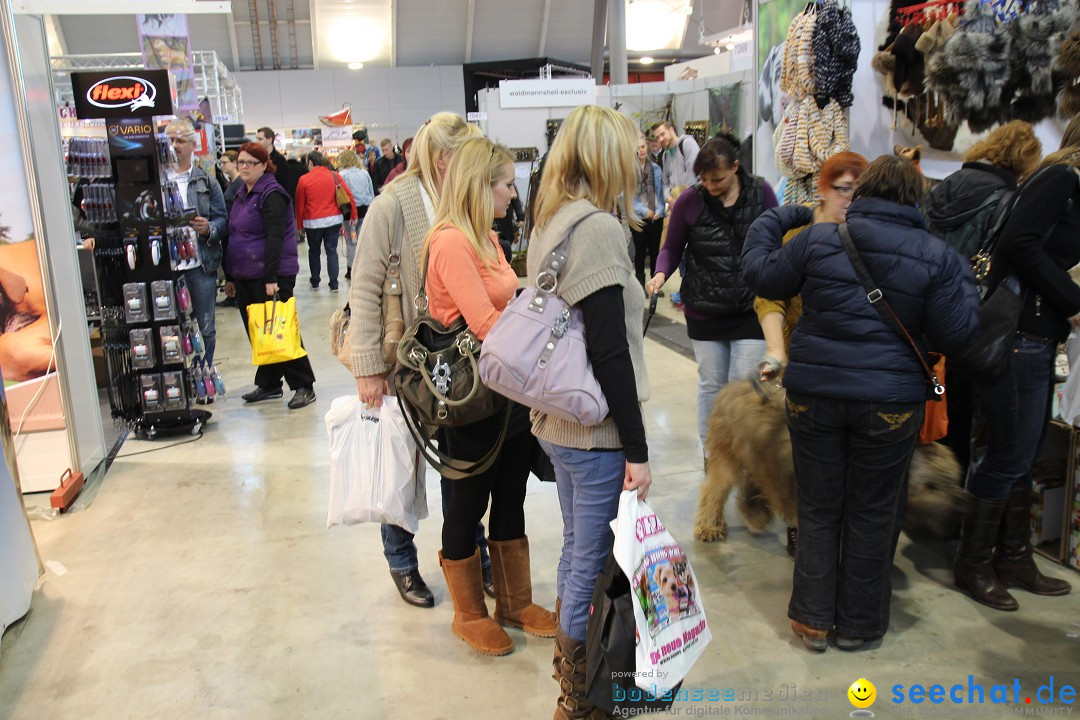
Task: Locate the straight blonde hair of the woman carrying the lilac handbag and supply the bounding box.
[536,105,640,228]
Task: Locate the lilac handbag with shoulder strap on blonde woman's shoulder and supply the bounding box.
[480,210,608,426]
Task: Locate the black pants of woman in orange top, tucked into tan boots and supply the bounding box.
[443,412,536,560]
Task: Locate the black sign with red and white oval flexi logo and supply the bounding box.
[71,70,173,120]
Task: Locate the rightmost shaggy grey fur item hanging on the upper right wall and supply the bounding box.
[1007,0,1072,123]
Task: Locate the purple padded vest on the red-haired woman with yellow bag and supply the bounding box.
[226,173,300,280]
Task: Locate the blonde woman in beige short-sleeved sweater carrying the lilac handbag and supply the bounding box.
[528,106,652,718]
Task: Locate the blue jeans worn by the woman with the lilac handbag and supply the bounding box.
[540,440,626,642]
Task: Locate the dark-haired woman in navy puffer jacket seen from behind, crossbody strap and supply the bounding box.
[743,155,978,651]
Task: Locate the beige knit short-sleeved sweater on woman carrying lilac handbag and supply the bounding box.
[528,200,649,450]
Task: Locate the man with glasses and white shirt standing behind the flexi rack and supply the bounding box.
[165,118,228,377]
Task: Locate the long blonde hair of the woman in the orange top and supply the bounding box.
[423,137,514,270]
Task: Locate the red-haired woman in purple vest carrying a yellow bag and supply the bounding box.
[228,142,315,410]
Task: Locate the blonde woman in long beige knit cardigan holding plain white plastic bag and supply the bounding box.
[349,112,483,608]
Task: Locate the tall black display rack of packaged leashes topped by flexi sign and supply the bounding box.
[67,70,217,439]
